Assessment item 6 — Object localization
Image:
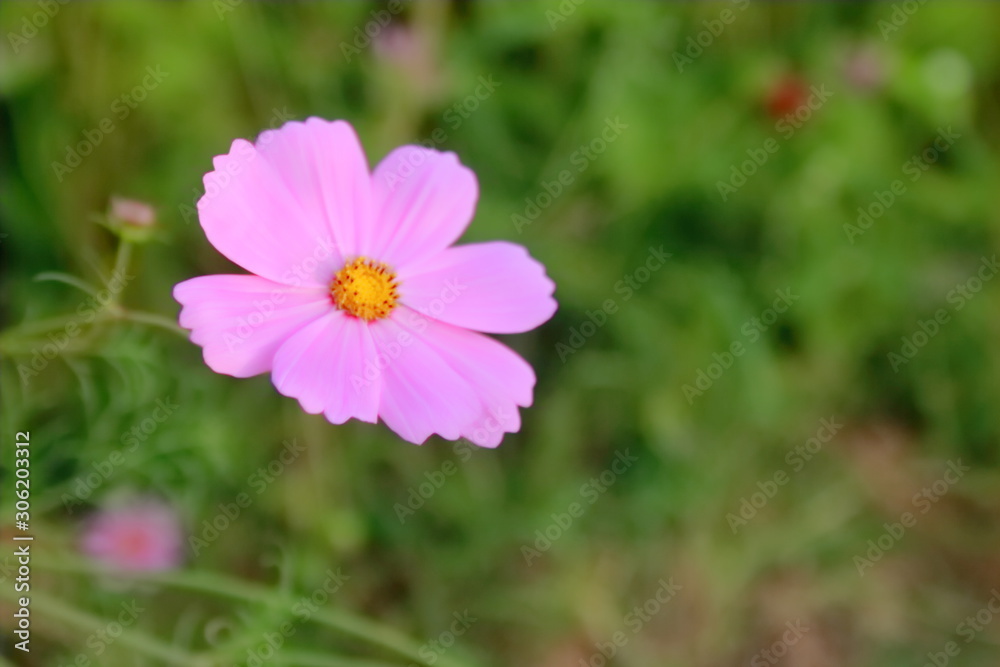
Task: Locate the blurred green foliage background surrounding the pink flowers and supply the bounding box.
[0,0,1000,667]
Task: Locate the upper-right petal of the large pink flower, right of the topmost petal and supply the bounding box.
[361,146,479,270]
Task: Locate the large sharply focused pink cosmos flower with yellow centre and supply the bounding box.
[174,118,556,447]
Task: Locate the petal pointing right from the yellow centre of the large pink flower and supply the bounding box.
[399,241,556,333]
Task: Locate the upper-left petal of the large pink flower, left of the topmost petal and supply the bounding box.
[198,139,343,286]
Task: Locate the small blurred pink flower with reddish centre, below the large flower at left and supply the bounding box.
[81,499,183,572]
